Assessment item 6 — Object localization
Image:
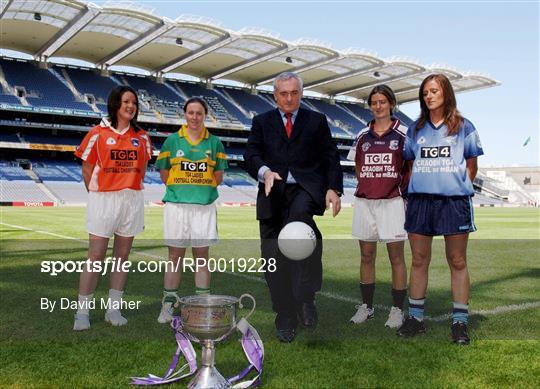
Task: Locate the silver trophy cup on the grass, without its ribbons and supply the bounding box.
[180,294,255,389]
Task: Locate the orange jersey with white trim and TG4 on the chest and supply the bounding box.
[75,120,152,192]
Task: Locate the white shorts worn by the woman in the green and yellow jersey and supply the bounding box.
[163,202,219,247]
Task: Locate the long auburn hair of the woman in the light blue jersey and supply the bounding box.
[415,74,463,135]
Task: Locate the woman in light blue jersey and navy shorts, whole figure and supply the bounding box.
[397,74,484,344]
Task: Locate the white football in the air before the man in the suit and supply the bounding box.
[278,222,317,261]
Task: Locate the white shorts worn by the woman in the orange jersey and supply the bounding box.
[86,189,144,238]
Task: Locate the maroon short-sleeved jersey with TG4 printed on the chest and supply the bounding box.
[347,119,409,199]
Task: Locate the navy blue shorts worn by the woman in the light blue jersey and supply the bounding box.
[405,193,476,236]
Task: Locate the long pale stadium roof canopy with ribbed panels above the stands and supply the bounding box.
[0,0,499,103]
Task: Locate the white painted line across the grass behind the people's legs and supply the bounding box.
[0,222,540,322]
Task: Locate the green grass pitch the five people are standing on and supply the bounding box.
[0,207,540,388]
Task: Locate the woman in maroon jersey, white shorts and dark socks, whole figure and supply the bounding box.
[347,85,408,328]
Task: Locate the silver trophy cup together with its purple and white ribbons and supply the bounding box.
[131,294,264,388]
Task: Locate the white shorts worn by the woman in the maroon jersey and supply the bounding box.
[352,197,407,243]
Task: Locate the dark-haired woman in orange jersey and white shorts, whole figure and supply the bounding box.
[73,86,152,331]
